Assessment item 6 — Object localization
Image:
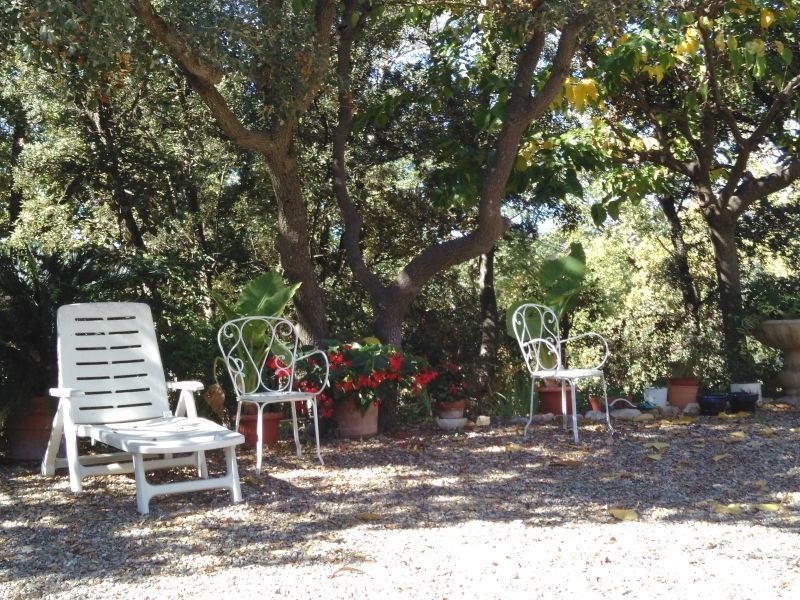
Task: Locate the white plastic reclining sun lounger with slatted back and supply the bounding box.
[42,302,244,514]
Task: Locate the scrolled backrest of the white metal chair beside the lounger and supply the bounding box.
[217,316,299,396]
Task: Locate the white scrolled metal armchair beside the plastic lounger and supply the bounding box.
[217,316,330,473]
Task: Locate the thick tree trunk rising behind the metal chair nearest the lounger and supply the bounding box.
[265,141,328,345]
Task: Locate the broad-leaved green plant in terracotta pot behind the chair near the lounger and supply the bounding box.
[211,270,300,448]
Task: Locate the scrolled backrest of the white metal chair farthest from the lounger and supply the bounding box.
[511,304,564,373]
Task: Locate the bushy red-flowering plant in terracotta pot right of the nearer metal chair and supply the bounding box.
[303,338,436,438]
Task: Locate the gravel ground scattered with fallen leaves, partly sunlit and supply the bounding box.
[0,405,800,600]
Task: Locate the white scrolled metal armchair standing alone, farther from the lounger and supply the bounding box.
[512,304,614,444]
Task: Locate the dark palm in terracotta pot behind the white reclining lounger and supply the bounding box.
[0,246,130,460]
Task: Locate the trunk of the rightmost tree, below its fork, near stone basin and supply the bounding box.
[703,210,753,379]
